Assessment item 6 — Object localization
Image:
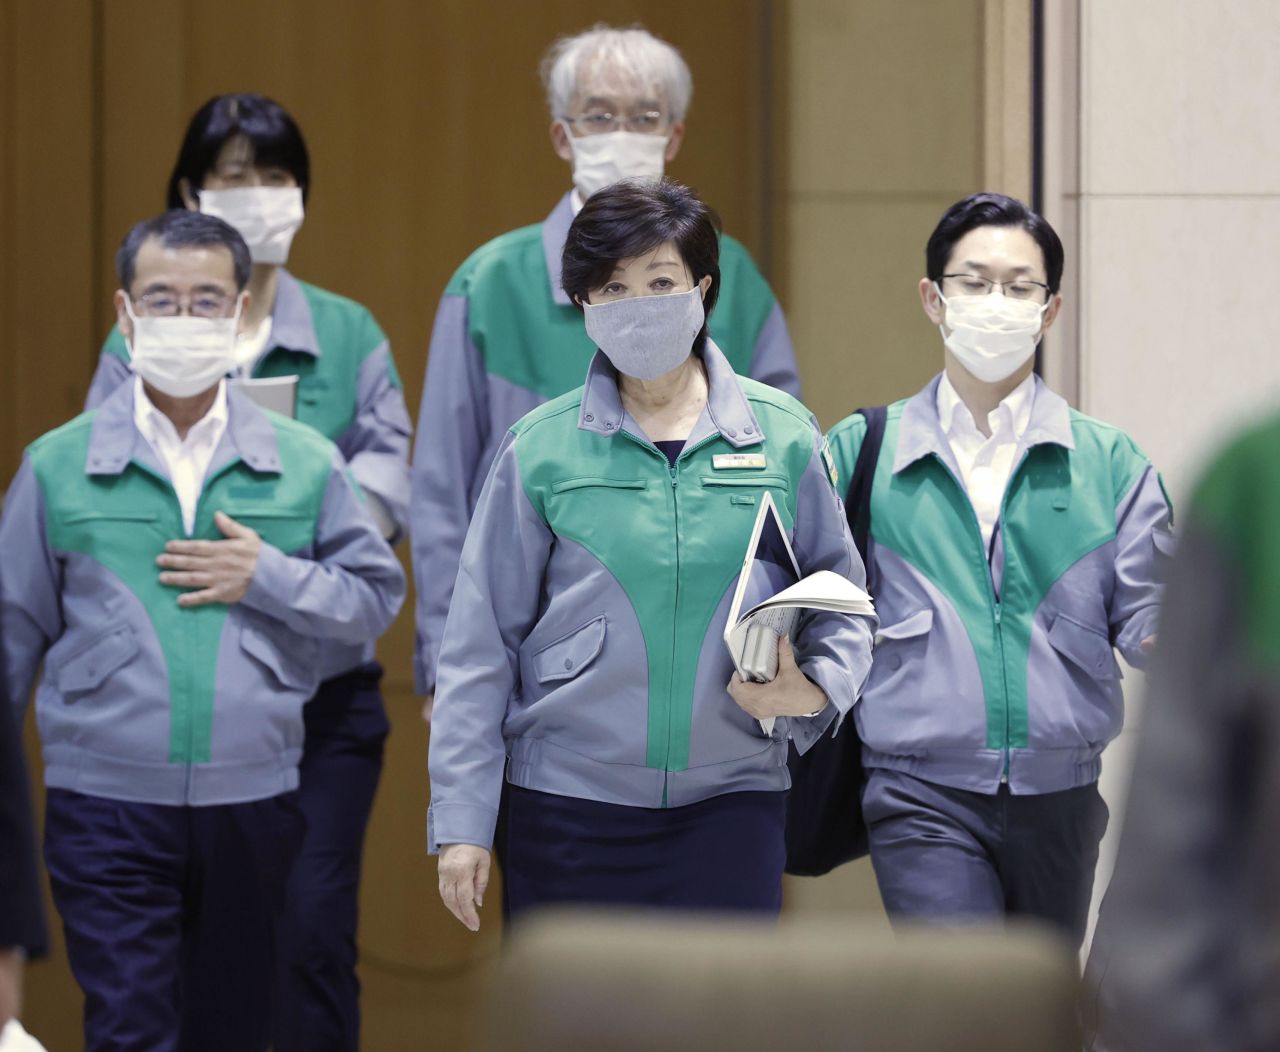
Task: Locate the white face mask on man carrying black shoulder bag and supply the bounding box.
[933,282,1048,384]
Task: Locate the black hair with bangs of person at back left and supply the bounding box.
[166,92,311,209]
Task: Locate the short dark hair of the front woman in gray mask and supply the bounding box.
[561,179,721,353]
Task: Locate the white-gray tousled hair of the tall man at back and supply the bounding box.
[539,22,694,120]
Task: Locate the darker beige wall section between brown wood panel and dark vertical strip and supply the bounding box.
[777,0,1030,437]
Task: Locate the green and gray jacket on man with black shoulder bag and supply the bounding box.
[828,378,1172,793]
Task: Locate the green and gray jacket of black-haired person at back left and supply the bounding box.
[84,270,412,680]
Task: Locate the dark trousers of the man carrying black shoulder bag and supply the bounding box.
[863,768,1108,947]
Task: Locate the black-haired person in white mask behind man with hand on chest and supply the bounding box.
[87,92,411,1052]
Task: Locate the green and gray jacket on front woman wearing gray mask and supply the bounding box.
[428,342,876,851]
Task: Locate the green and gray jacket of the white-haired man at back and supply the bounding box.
[411,193,800,694]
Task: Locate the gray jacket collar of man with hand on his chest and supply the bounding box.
[84,384,280,479]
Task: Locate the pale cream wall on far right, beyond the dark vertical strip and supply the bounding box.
[1046,0,1280,957]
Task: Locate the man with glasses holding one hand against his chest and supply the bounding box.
[0,210,404,1049]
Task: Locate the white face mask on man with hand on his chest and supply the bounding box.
[124,297,244,398]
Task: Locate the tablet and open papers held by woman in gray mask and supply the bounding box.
[724,493,874,735]
